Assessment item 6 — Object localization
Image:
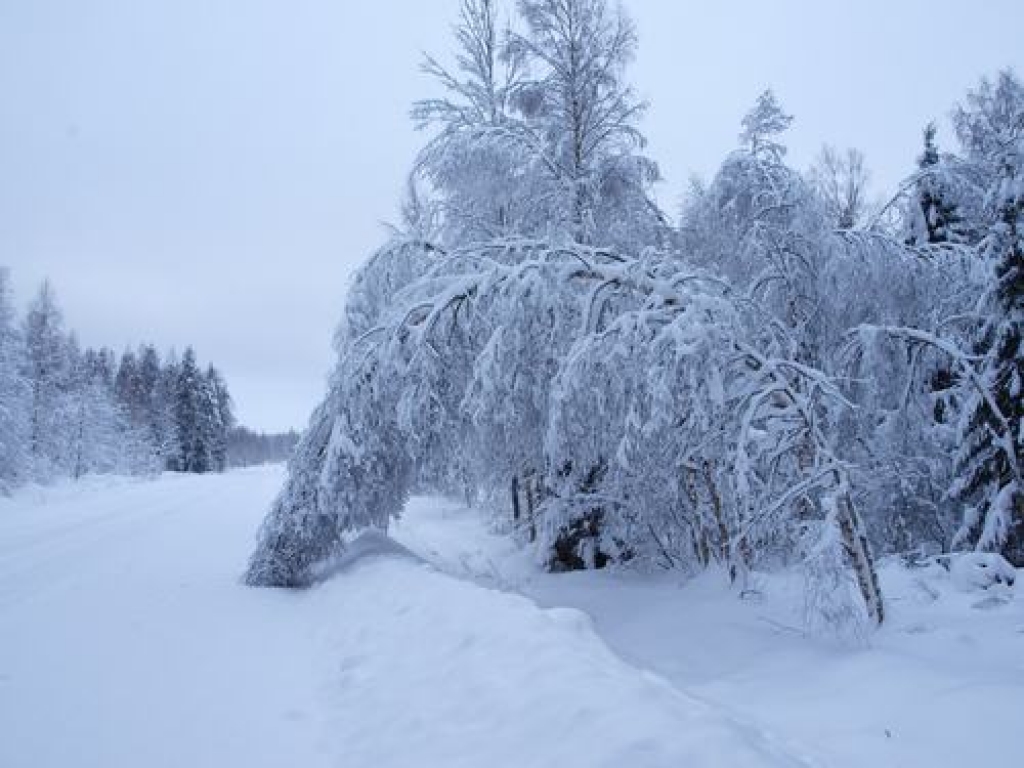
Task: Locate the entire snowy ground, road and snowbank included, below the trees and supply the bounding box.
[0,469,1024,768]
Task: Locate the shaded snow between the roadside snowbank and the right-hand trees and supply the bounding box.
[393,499,1024,768]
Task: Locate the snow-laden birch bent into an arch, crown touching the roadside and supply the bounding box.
[247,240,883,622]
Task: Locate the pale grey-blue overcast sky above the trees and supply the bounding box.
[0,0,1024,429]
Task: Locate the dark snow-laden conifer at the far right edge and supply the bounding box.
[843,73,1024,561]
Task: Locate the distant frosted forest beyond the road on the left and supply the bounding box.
[0,276,234,489]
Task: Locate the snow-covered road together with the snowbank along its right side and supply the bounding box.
[0,469,803,768]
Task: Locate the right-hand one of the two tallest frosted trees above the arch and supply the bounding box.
[508,0,663,250]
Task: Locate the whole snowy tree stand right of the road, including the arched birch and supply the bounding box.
[248,0,1024,625]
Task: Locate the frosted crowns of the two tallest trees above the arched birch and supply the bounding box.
[407,0,666,249]
